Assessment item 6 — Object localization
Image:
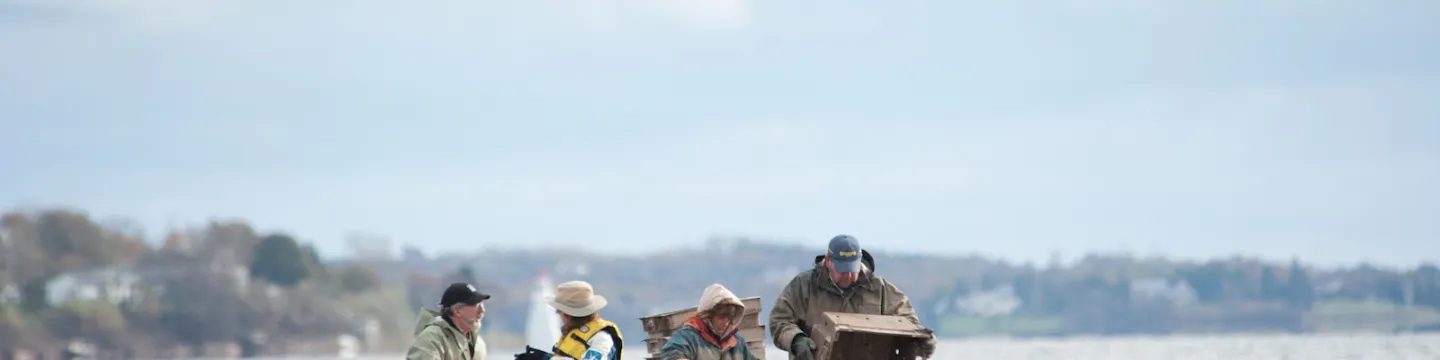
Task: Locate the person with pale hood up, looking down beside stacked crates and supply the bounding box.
[660,284,759,360]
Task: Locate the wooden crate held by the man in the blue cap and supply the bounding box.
[812,312,933,360]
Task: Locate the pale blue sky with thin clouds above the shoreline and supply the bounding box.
[0,0,1440,266]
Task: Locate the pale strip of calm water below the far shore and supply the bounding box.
[275,334,1440,360]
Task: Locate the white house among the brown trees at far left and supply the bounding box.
[45,268,141,305]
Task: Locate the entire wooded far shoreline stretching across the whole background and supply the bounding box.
[0,210,1440,357]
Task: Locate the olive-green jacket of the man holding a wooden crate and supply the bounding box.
[769,251,935,359]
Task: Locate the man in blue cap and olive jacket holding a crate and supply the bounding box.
[770,235,936,360]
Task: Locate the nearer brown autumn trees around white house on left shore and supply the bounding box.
[0,210,405,357]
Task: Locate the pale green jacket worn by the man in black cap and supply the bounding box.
[405,308,487,360]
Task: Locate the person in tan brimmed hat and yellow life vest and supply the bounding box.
[516,281,625,360]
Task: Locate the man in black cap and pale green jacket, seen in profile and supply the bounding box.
[405,282,490,360]
